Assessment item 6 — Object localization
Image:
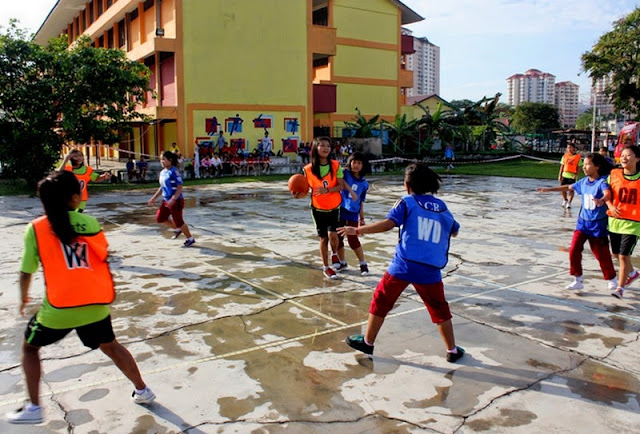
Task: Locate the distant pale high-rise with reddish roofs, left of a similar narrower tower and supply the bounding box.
[507,69,556,107]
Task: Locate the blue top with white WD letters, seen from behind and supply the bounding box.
[387,195,460,283]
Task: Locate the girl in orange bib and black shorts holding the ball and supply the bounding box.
[292,137,344,279]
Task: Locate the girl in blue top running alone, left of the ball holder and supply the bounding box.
[148,151,196,247]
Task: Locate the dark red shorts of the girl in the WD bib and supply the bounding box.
[369,271,451,324]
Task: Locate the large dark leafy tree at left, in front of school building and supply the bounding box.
[0,22,150,185]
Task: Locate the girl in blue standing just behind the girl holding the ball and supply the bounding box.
[332,152,370,276]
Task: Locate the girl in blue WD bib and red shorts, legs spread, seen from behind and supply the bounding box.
[338,164,464,362]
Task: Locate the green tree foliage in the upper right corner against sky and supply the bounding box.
[582,8,640,115]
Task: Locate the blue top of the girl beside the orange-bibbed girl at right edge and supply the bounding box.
[571,176,610,238]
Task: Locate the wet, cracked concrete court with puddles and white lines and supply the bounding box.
[0,176,640,433]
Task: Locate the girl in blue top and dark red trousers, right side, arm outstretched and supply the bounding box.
[537,154,618,291]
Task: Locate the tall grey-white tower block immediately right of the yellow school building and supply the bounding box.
[402,28,440,96]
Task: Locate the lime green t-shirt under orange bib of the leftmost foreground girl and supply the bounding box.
[20,211,110,329]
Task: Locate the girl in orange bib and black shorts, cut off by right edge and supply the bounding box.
[607,146,640,298]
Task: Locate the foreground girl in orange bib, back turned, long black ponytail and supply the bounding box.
[7,171,156,424]
